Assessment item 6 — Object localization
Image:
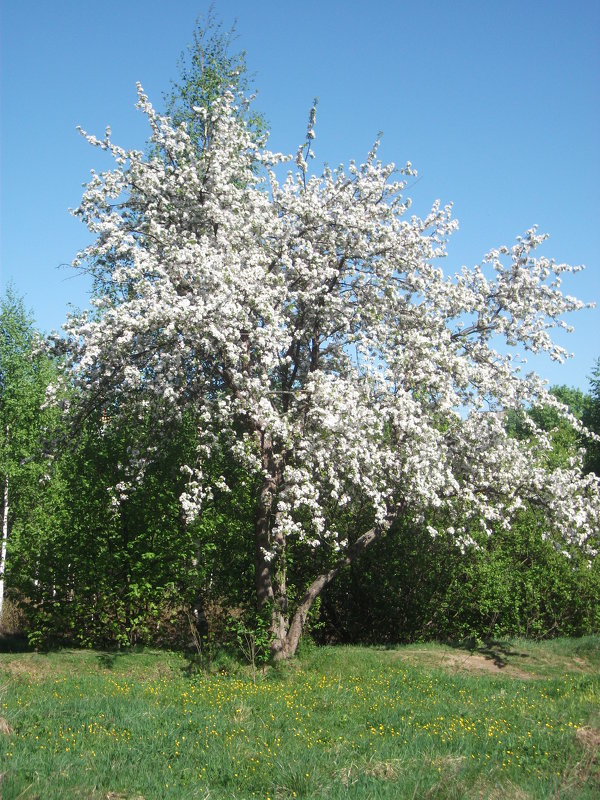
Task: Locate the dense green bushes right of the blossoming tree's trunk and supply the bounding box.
[318,512,600,643]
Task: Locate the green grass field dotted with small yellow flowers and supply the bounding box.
[0,637,600,800]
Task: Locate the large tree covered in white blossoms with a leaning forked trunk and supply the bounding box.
[57,89,600,658]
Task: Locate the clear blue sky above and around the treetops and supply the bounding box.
[1,0,600,389]
